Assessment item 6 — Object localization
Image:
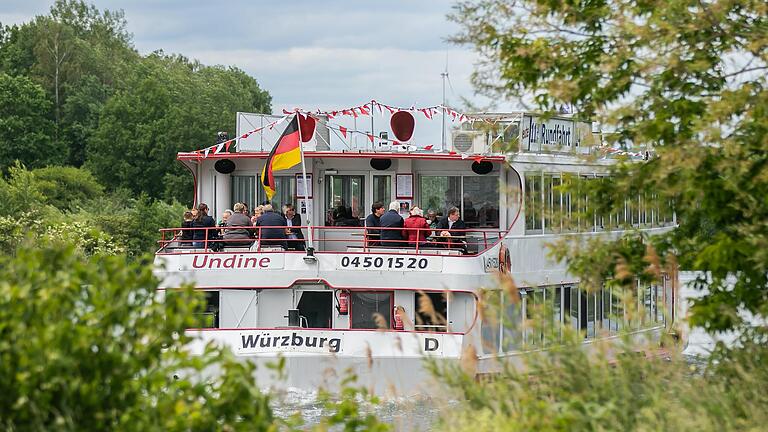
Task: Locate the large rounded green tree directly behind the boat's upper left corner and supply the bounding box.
[87,54,270,200]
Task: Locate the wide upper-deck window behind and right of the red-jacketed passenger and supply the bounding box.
[415,175,499,228]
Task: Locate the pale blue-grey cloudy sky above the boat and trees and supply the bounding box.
[0,0,498,112]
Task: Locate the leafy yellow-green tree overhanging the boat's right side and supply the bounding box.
[452,0,768,331]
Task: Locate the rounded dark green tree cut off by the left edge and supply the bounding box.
[0,73,58,171]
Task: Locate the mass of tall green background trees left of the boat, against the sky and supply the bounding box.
[0,0,271,201]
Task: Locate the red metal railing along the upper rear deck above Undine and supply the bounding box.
[157,226,506,255]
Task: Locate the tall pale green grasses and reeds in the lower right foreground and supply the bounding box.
[429,299,768,431]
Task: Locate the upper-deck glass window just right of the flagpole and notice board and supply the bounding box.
[325,175,364,226]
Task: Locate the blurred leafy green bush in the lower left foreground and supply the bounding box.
[0,242,276,431]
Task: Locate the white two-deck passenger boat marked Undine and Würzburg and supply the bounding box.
[156,110,675,395]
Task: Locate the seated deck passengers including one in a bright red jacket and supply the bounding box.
[365,202,467,249]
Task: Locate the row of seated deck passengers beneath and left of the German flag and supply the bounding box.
[180,203,305,251]
